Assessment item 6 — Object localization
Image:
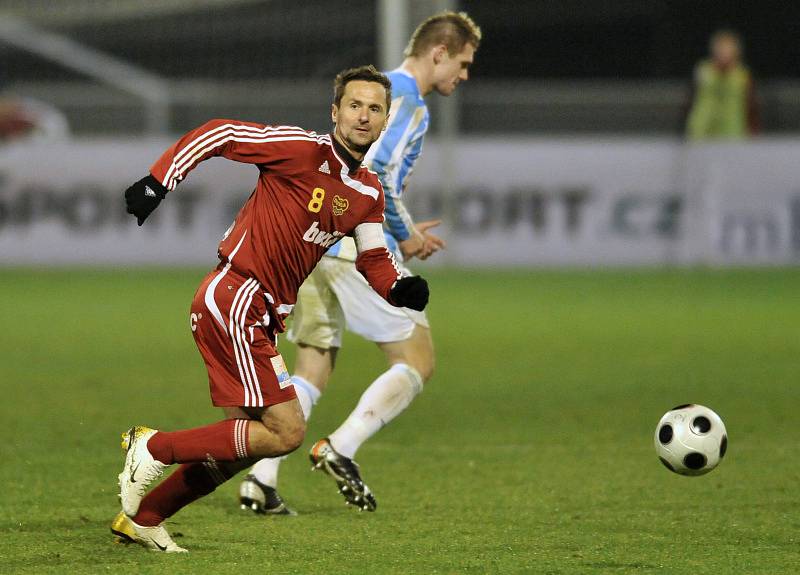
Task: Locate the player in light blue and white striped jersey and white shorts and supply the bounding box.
[239,11,481,515]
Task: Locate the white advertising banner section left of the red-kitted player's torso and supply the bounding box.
[0,140,258,266]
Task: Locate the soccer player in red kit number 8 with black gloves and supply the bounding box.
[111,66,428,552]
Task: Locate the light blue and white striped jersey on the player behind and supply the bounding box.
[325,68,430,260]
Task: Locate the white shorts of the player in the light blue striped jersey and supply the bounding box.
[287,256,429,349]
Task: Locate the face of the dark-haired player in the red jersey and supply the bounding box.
[331,80,389,154]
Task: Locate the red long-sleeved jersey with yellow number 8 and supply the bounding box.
[150,120,400,330]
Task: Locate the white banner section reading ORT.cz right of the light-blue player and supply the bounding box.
[408,139,683,265]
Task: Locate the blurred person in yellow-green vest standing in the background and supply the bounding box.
[686,30,759,140]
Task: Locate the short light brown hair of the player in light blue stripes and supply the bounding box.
[404,10,482,58]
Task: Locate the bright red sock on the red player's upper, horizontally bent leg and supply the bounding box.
[147,419,250,466]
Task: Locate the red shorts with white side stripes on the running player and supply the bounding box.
[190,264,297,407]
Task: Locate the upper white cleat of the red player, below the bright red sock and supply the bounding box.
[119,425,167,517]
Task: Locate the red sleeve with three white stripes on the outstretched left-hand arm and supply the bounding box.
[150,120,318,191]
